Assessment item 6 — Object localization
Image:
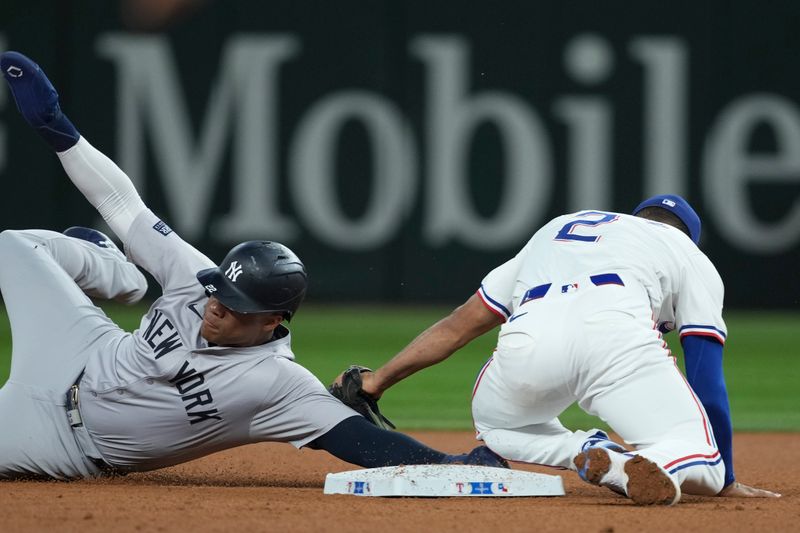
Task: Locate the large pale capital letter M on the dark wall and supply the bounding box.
[97,33,299,242]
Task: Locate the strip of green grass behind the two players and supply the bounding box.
[0,306,800,431]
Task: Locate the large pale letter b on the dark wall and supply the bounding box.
[411,36,553,250]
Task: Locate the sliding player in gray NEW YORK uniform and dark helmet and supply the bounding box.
[0,52,507,479]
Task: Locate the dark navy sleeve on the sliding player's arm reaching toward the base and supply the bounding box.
[308,415,448,468]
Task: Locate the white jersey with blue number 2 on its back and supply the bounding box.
[479,211,726,344]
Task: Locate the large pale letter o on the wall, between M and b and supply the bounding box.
[289,91,417,250]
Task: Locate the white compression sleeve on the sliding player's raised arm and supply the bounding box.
[58,137,147,244]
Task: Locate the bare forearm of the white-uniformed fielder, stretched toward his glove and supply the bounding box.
[362,294,502,398]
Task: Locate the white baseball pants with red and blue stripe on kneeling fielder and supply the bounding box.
[472,278,725,495]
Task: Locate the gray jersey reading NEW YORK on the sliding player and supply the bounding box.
[74,211,356,470]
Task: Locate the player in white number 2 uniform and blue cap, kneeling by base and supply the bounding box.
[344,203,779,498]
